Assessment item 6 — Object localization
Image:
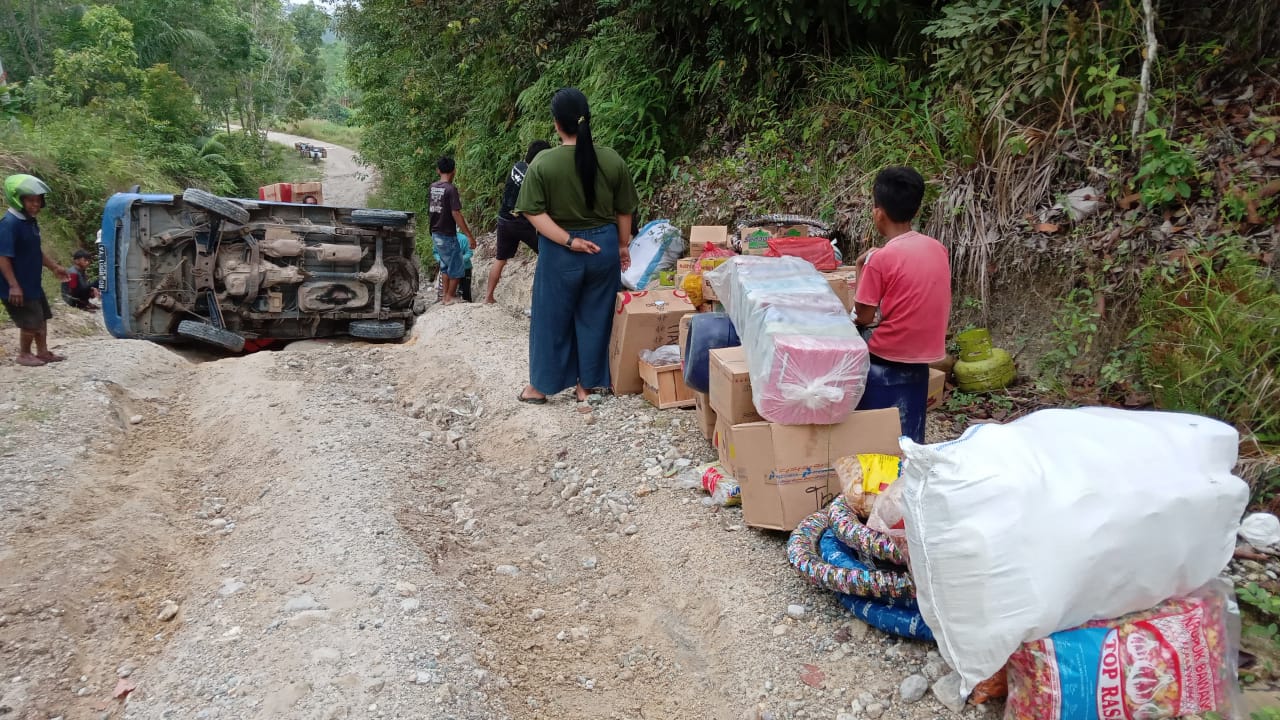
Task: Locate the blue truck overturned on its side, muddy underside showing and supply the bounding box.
[99,190,425,352]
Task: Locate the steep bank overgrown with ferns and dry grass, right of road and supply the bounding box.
[338,0,1280,486]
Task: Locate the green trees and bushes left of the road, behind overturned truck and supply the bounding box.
[0,0,330,275]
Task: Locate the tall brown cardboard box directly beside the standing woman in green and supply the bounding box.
[609,290,694,395]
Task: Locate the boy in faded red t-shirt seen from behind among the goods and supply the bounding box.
[854,168,951,442]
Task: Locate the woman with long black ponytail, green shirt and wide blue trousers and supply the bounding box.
[516,87,640,407]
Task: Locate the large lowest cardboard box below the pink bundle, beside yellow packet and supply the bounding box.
[717,407,902,530]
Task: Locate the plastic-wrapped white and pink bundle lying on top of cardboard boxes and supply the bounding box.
[707,256,870,425]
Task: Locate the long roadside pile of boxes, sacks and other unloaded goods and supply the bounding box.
[611,211,1248,720]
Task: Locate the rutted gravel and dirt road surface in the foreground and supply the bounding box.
[0,135,1269,720]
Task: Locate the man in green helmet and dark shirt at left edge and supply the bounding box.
[0,176,67,368]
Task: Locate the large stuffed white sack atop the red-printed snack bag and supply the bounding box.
[899,407,1249,696]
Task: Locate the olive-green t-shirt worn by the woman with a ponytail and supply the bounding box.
[515,145,640,231]
